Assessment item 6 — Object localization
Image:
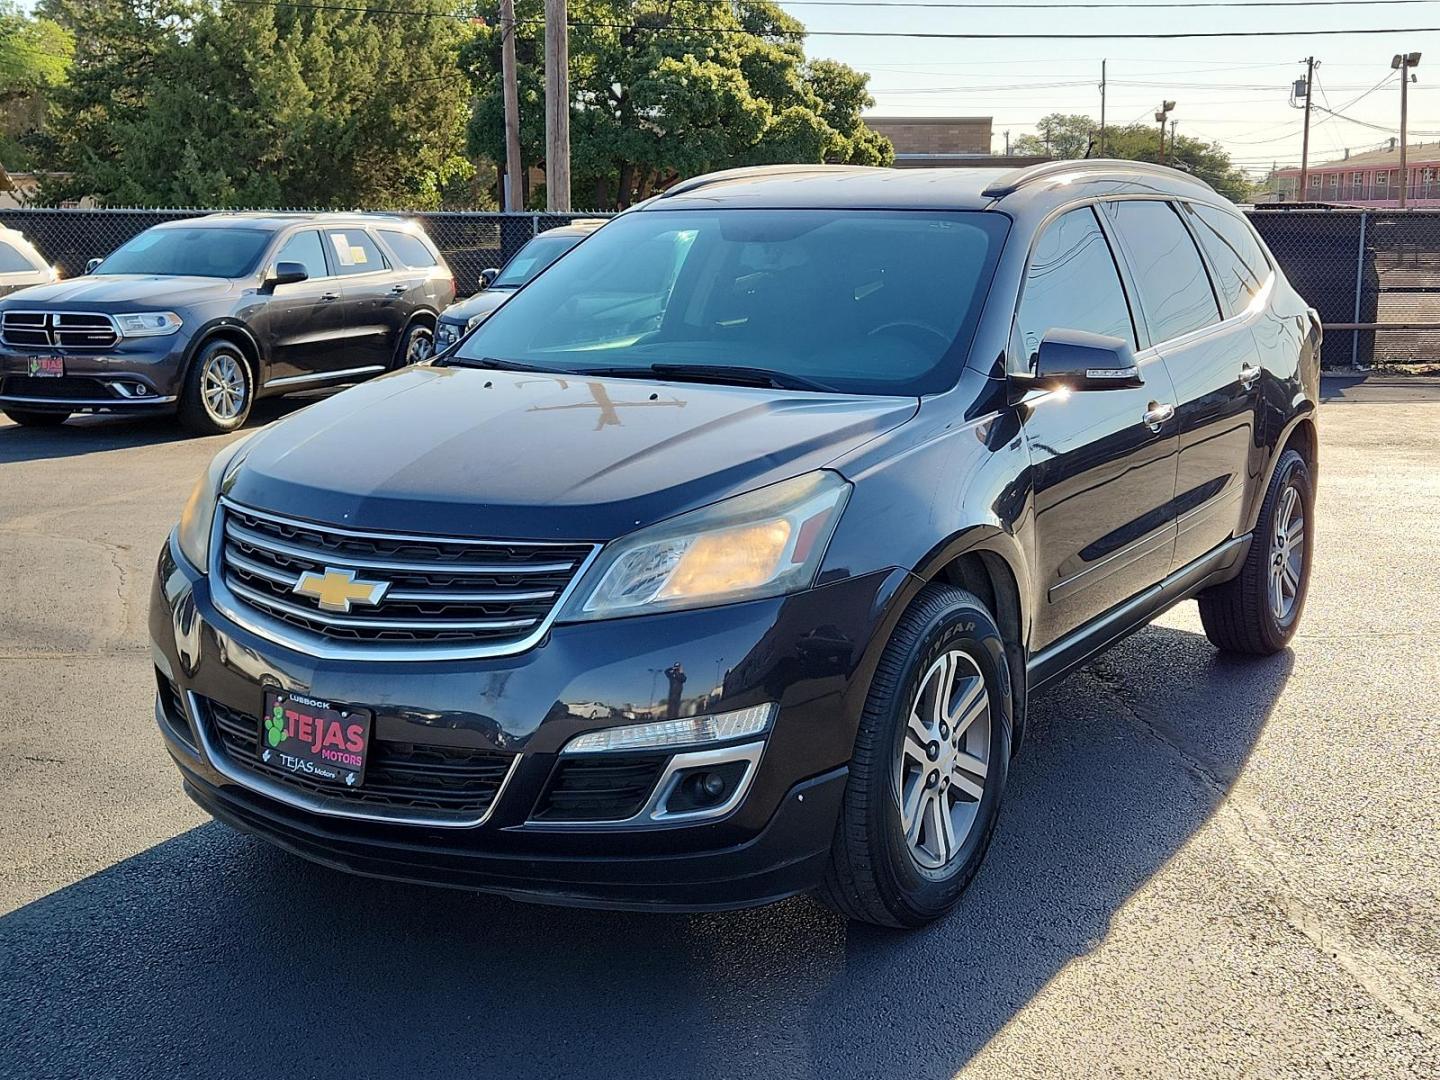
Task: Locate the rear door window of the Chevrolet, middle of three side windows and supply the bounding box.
[1104,200,1220,344]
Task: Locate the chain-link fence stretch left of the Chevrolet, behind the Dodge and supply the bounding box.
[0,209,605,297]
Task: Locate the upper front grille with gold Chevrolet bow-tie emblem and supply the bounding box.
[215,501,596,657]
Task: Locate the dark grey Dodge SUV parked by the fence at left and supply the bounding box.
[0,213,455,435]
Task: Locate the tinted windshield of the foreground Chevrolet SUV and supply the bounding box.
[458,210,1008,395]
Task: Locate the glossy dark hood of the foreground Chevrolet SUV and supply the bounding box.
[226,366,917,540]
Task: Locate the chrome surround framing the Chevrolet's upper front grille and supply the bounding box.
[206,498,600,662]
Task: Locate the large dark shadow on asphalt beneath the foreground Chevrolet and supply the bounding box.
[0,628,1292,1080]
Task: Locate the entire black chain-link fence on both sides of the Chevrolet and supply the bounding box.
[8,207,1440,367]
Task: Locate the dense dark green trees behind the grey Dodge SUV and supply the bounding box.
[36,0,471,209]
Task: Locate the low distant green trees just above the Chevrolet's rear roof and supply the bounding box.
[1014,112,1251,202]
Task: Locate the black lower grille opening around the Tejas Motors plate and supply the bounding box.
[200,698,514,818]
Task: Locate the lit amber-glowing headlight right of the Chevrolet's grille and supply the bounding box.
[560,471,850,622]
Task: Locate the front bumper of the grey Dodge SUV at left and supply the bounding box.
[0,330,190,412]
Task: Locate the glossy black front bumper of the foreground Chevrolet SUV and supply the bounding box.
[151,544,907,910]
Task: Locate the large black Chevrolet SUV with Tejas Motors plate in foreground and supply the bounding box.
[150,161,1320,926]
